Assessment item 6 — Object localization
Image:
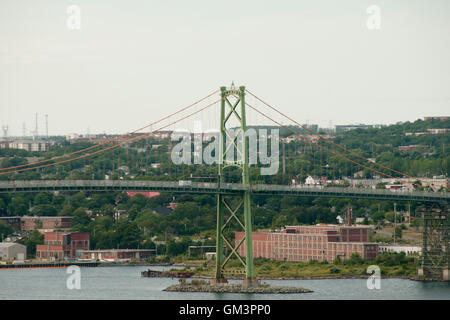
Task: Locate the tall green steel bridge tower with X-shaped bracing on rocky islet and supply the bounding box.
[212,84,257,286]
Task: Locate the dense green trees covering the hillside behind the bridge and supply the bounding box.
[0,120,444,262]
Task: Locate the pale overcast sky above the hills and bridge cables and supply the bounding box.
[0,0,450,135]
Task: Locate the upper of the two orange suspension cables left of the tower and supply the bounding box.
[0,90,219,174]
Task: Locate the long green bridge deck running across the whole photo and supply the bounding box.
[0,180,450,204]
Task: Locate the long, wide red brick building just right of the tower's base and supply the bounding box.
[235,225,378,262]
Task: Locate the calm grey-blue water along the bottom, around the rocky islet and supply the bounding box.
[0,266,450,300]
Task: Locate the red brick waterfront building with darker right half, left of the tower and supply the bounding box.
[36,232,89,260]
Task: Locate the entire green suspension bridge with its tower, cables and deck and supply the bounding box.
[0,85,450,286]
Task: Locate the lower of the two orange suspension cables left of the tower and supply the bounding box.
[0,99,222,175]
